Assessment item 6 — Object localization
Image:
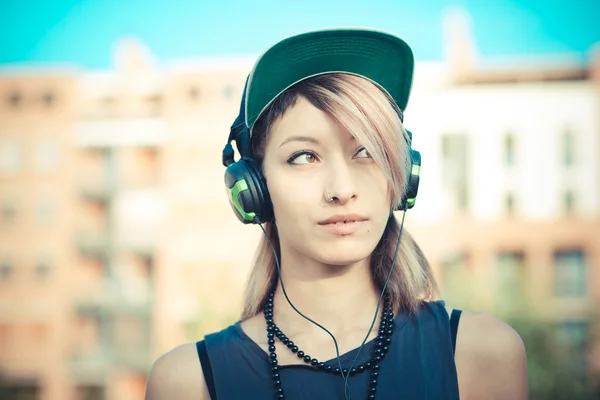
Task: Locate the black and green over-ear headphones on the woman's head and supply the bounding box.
[222,76,421,224]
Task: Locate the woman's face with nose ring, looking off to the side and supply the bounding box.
[263,97,390,265]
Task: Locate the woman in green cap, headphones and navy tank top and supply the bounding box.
[146,29,527,400]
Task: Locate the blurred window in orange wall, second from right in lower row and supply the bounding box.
[497,251,526,298]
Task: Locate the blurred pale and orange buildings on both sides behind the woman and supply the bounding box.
[0,3,600,400]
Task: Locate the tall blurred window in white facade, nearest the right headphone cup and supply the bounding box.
[441,134,470,212]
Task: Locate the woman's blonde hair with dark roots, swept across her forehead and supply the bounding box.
[241,73,438,320]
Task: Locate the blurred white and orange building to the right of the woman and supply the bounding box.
[405,10,600,368]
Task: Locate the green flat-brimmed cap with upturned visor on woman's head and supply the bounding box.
[245,28,414,128]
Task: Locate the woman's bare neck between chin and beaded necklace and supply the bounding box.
[274,250,382,335]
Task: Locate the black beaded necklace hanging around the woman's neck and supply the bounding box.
[263,292,394,399]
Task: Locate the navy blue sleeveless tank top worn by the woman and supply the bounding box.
[196,300,460,400]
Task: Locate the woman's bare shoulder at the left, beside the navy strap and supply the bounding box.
[145,343,210,400]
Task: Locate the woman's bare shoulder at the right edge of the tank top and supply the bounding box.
[455,311,528,400]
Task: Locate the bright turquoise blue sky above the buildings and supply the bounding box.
[0,0,600,69]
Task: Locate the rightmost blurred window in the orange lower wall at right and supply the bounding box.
[554,250,587,297]
